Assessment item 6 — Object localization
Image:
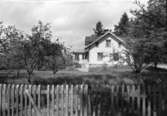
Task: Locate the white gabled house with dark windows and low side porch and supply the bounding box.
[73,31,127,67]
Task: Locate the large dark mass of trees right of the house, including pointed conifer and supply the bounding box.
[115,0,167,72]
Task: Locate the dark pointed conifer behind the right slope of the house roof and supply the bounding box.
[114,13,129,36]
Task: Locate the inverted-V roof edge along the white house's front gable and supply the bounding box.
[85,31,126,49]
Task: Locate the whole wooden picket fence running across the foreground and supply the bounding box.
[0,84,167,116]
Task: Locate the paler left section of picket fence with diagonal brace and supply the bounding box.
[0,84,88,116]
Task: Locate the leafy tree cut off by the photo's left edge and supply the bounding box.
[0,23,24,69]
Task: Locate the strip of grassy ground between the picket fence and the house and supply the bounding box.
[0,67,167,84]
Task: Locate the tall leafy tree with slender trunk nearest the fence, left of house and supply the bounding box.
[15,21,51,82]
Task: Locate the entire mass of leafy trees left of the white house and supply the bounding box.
[0,21,70,82]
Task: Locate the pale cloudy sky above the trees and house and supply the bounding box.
[0,0,147,49]
